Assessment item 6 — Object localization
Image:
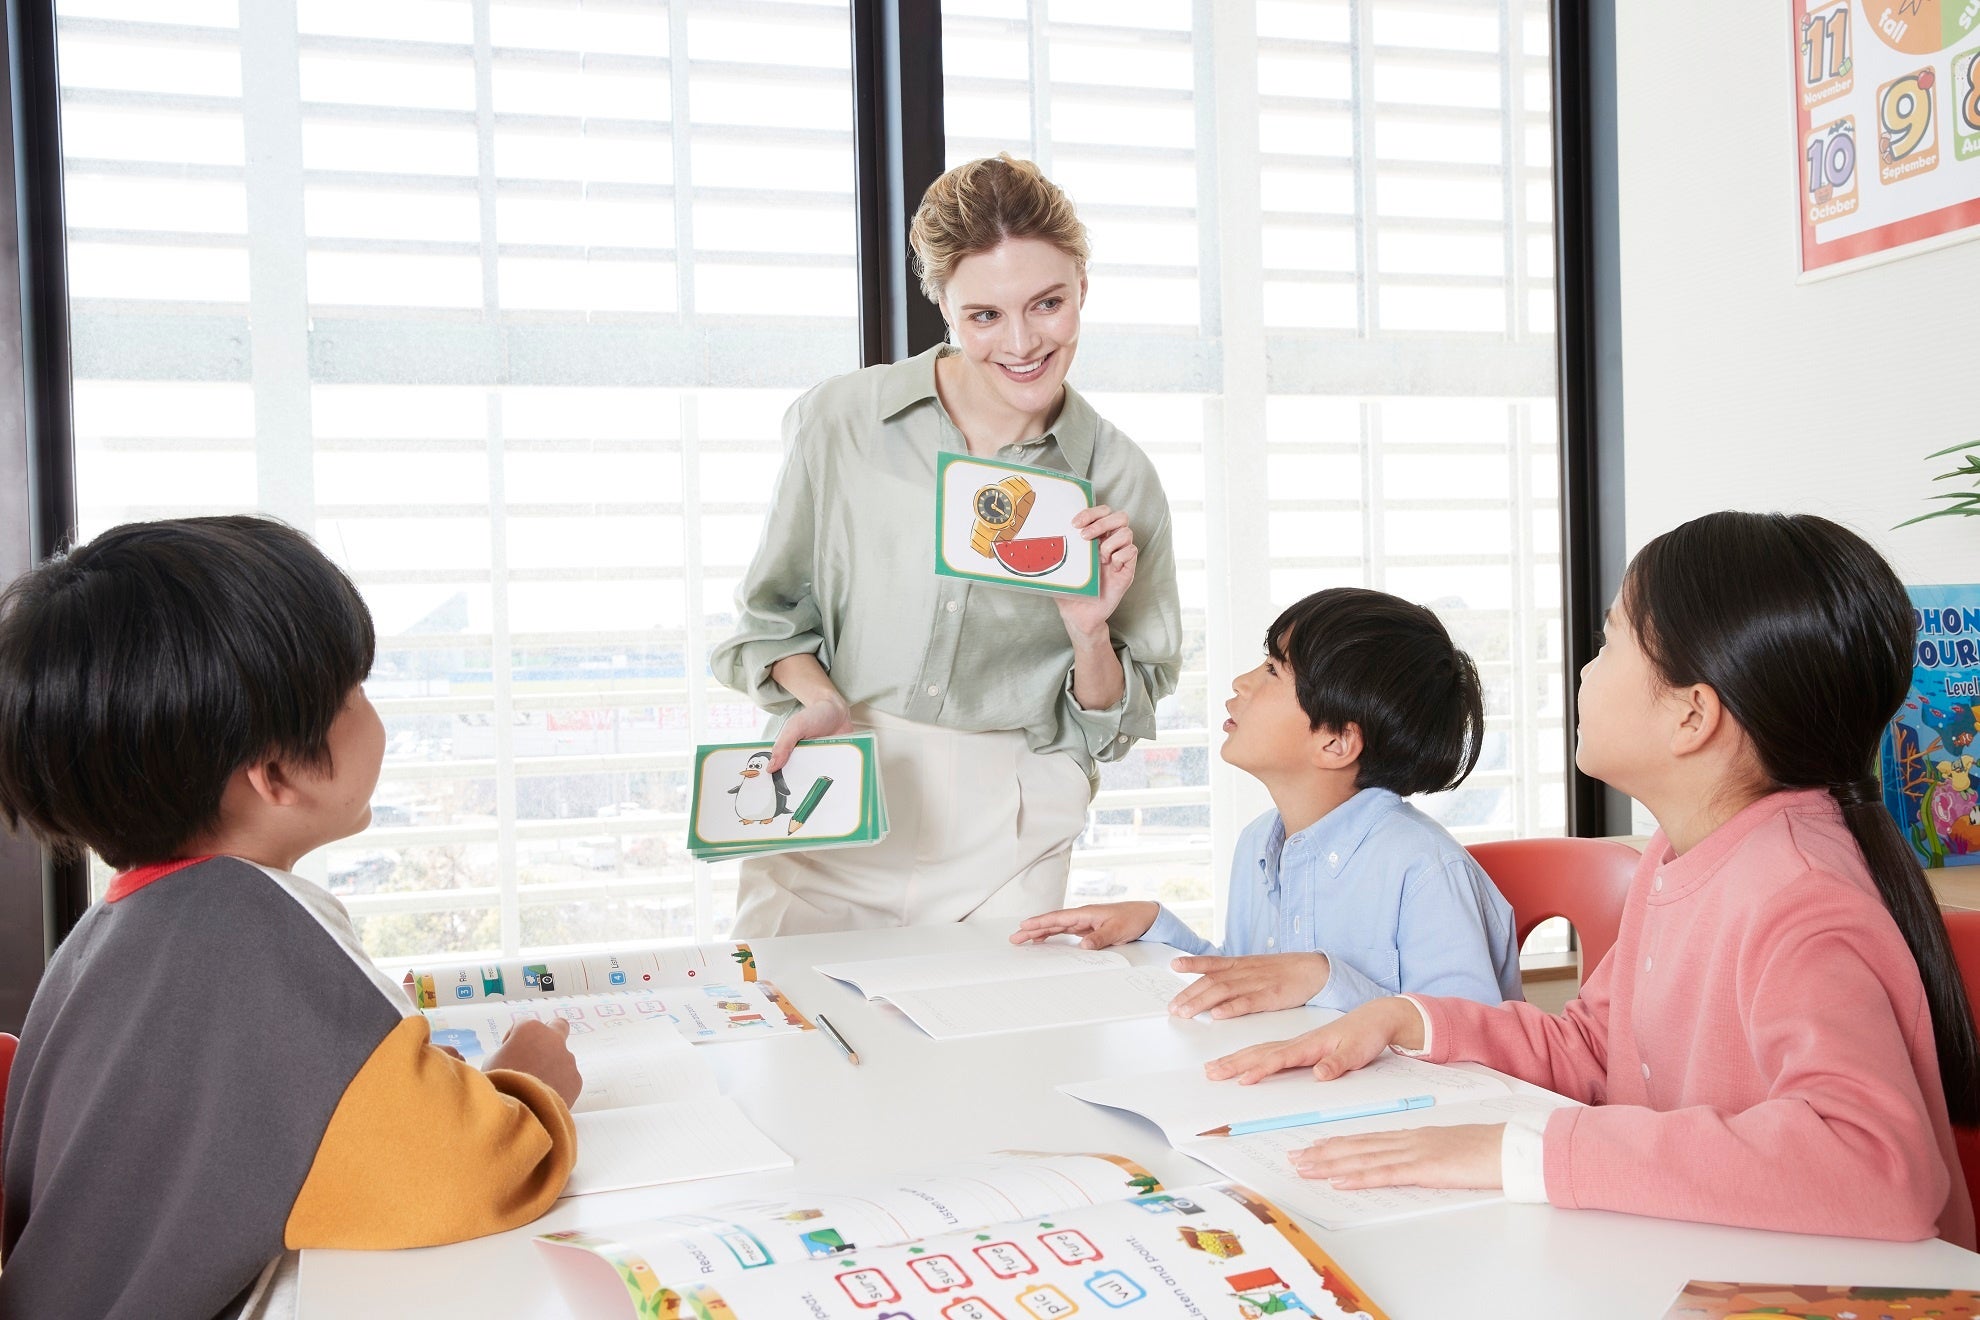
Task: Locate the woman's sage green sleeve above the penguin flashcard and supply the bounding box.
[709,396,832,714]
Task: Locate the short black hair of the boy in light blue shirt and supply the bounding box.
[1265,586,1485,798]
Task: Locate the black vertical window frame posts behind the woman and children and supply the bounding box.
[0,0,1628,1031]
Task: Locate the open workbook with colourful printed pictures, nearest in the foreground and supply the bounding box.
[537,1152,1384,1320]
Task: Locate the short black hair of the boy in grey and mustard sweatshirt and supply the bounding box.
[0,517,376,871]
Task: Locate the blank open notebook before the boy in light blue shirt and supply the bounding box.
[816,944,1188,1041]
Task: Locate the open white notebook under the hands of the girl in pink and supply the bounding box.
[1059,1055,1574,1229]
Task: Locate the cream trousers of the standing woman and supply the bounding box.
[731,707,1093,938]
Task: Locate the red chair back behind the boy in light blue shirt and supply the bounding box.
[1467,839,1643,982]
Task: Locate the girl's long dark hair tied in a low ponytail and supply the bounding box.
[1622,513,1980,1124]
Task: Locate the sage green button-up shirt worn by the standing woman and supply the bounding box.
[709,346,1182,782]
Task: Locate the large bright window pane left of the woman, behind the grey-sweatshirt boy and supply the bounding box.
[57,0,859,960]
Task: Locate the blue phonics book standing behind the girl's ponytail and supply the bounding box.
[1879,586,1980,867]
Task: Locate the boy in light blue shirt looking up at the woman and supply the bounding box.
[1012,588,1523,1017]
